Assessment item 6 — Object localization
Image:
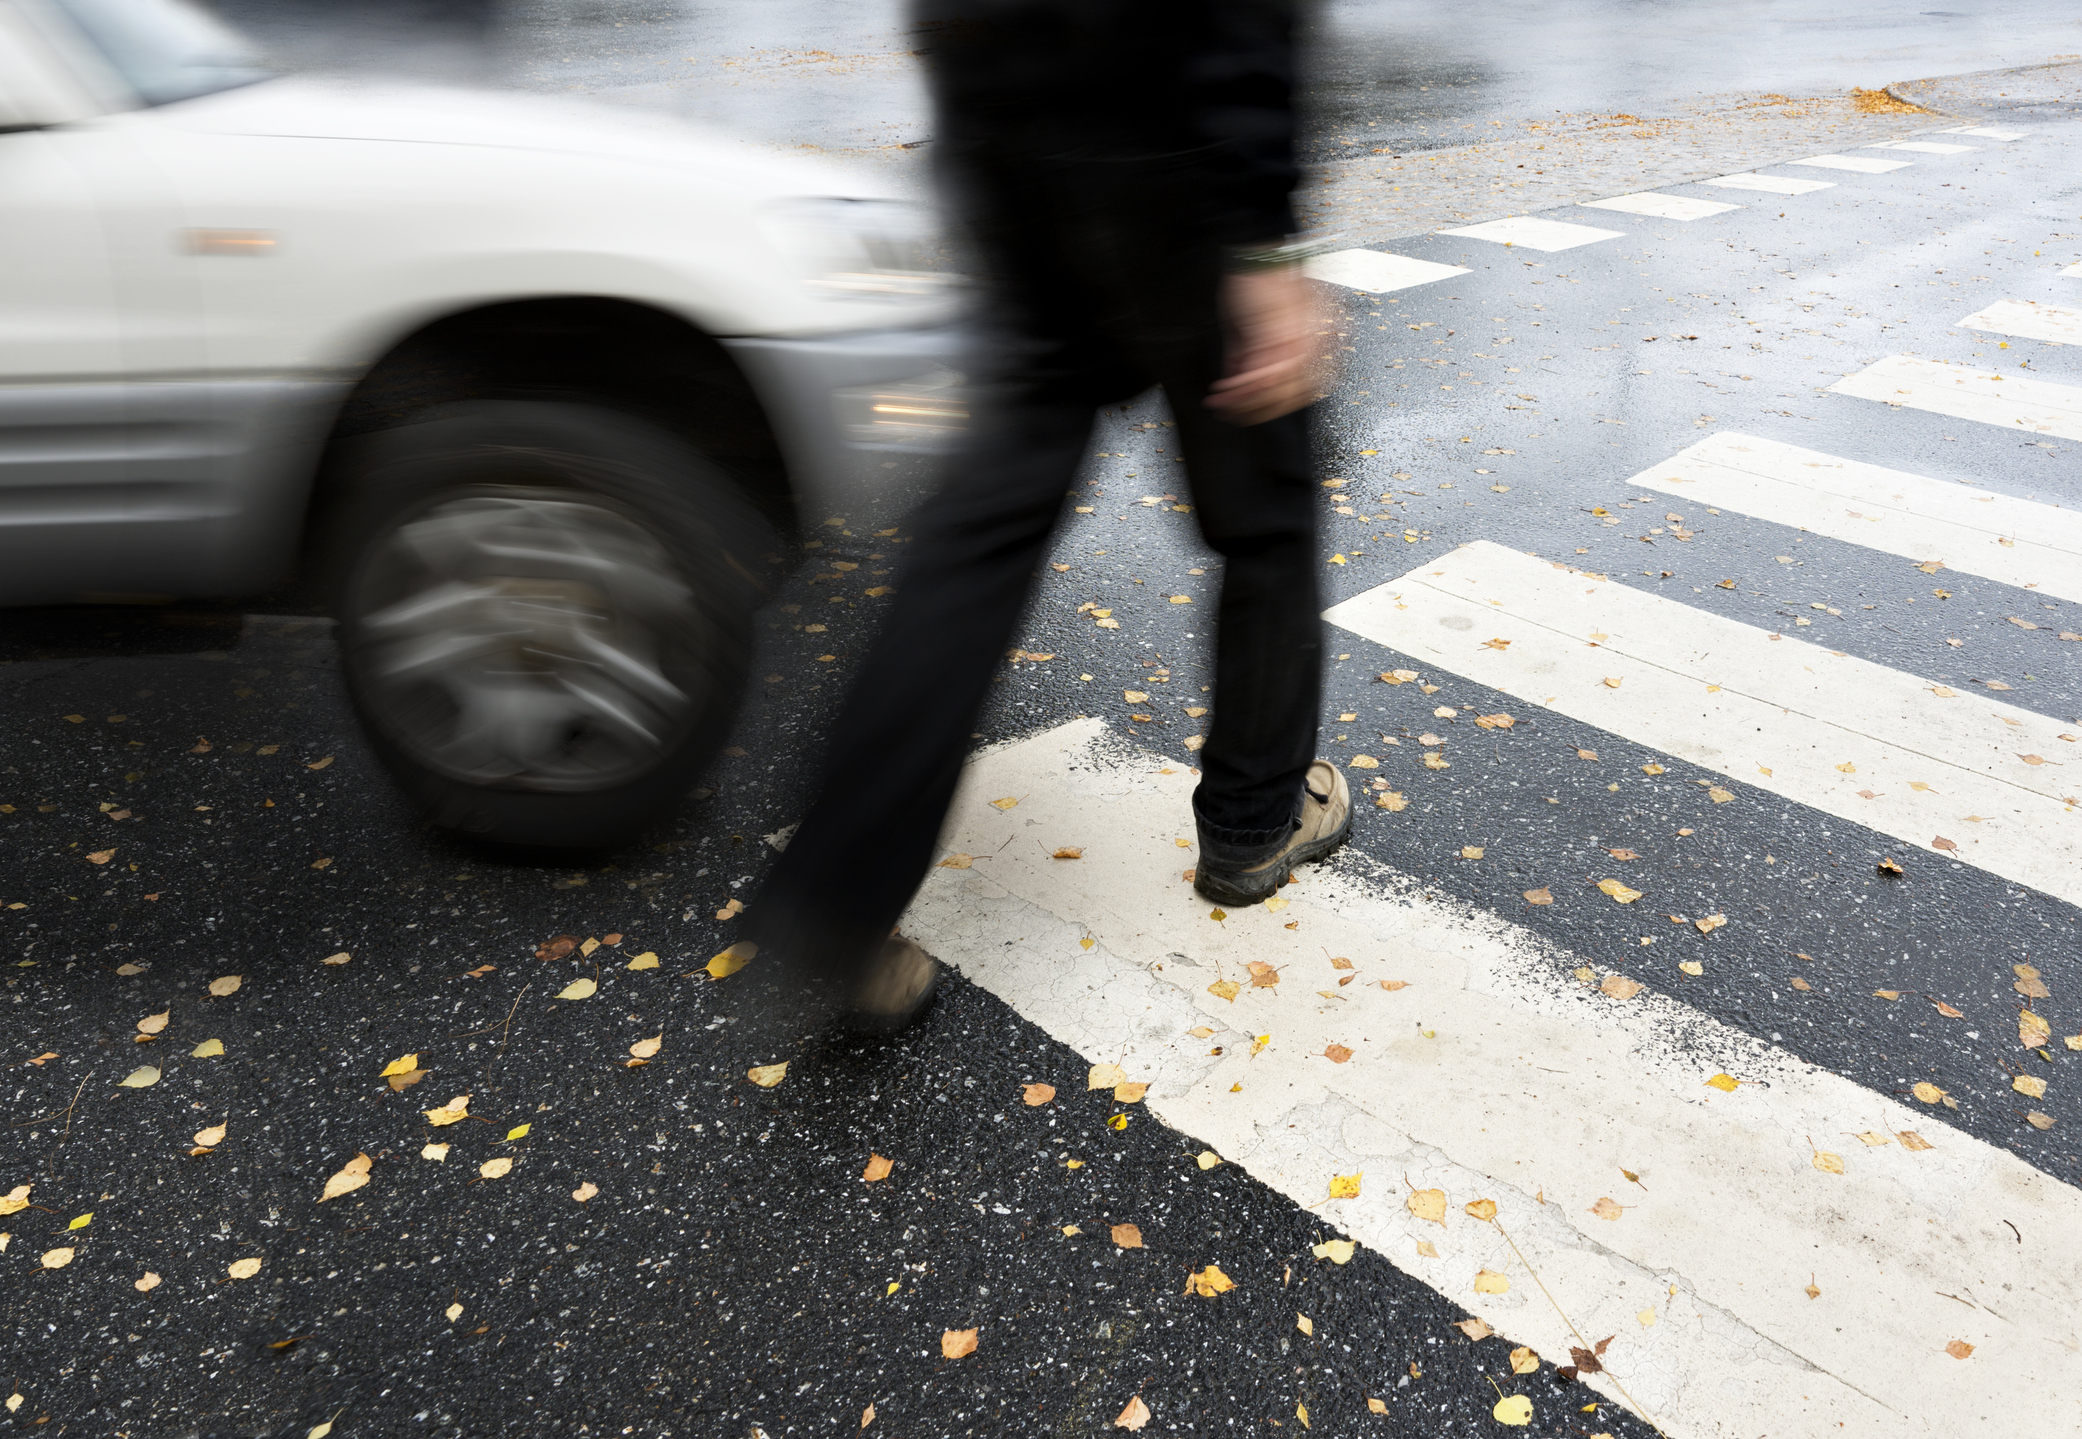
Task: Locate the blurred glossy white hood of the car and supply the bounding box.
[133,77,899,198]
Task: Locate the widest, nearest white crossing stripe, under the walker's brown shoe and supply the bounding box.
[916,721,2082,1439]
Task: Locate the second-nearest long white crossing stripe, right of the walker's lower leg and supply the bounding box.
[1324,539,2082,904]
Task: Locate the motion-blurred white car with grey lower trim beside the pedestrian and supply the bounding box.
[0,0,962,848]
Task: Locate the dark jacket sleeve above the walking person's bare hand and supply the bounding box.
[1180,0,1301,244]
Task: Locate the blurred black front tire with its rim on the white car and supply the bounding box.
[327,400,764,850]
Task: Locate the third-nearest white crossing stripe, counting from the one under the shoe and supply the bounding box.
[1626,433,2082,603]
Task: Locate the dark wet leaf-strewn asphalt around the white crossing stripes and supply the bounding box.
[0,17,2082,1439]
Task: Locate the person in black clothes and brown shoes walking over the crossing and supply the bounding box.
[745,0,1351,1031]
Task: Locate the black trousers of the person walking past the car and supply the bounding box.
[745,196,1322,983]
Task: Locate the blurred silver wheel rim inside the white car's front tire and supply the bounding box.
[348,489,708,791]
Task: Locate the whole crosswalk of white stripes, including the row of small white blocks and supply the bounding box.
[924,127,2082,1439]
